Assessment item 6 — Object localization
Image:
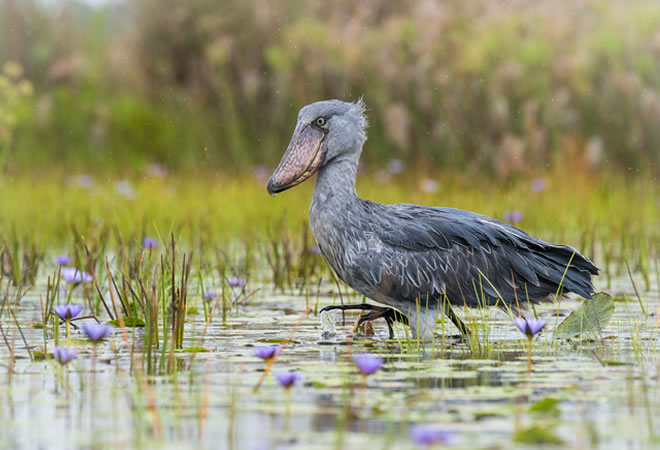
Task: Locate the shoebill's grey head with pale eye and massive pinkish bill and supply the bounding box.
[267,99,367,195]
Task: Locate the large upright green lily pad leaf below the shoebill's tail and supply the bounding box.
[554,292,614,339]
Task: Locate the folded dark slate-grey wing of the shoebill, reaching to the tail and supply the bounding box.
[352,201,598,306]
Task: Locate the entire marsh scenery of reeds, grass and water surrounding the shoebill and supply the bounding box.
[0,0,660,449]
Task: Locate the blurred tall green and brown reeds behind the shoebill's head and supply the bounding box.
[0,0,660,179]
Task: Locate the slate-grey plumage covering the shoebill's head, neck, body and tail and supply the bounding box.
[269,100,598,338]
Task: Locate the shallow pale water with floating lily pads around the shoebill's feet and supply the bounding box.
[0,268,660,449]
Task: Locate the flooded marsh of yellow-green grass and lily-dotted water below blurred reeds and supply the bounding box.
[0,176,660,448]
